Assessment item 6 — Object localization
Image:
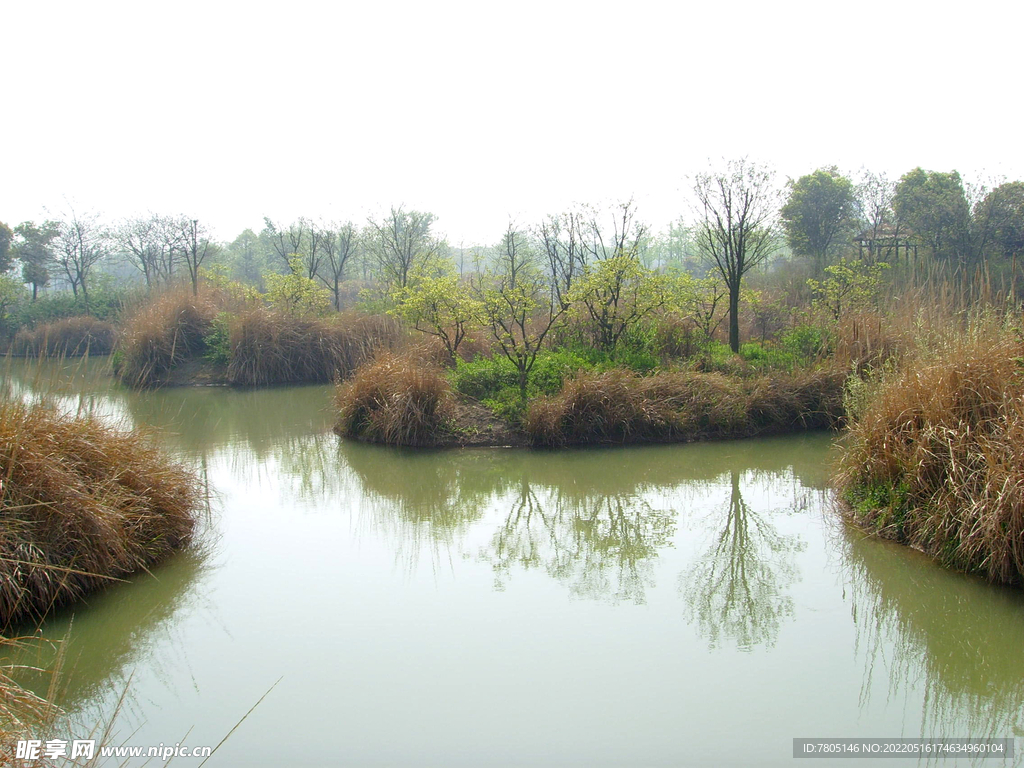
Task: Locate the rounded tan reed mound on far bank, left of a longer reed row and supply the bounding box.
[117,288,218,387]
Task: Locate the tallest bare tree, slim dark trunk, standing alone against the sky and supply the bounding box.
[693,158,781,352]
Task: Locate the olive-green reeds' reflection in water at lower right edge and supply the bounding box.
[835,527,1024,745]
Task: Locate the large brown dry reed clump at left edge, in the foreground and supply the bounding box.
[0,401,202,627]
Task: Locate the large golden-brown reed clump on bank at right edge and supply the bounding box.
[838,322,1024,584]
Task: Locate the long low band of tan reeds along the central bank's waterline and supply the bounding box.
[335,352,846,446]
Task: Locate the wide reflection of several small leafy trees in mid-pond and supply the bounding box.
[484,477,676,604]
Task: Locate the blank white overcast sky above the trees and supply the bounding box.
[0,0,1024,245]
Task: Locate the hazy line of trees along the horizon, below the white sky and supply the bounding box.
[0,159,1024,356]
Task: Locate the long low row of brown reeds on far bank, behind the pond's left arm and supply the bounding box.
[227,308,400,387]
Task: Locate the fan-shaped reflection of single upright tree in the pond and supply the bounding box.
[680,469,806,650]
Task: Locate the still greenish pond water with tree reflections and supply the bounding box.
[5,360,1024,766]
